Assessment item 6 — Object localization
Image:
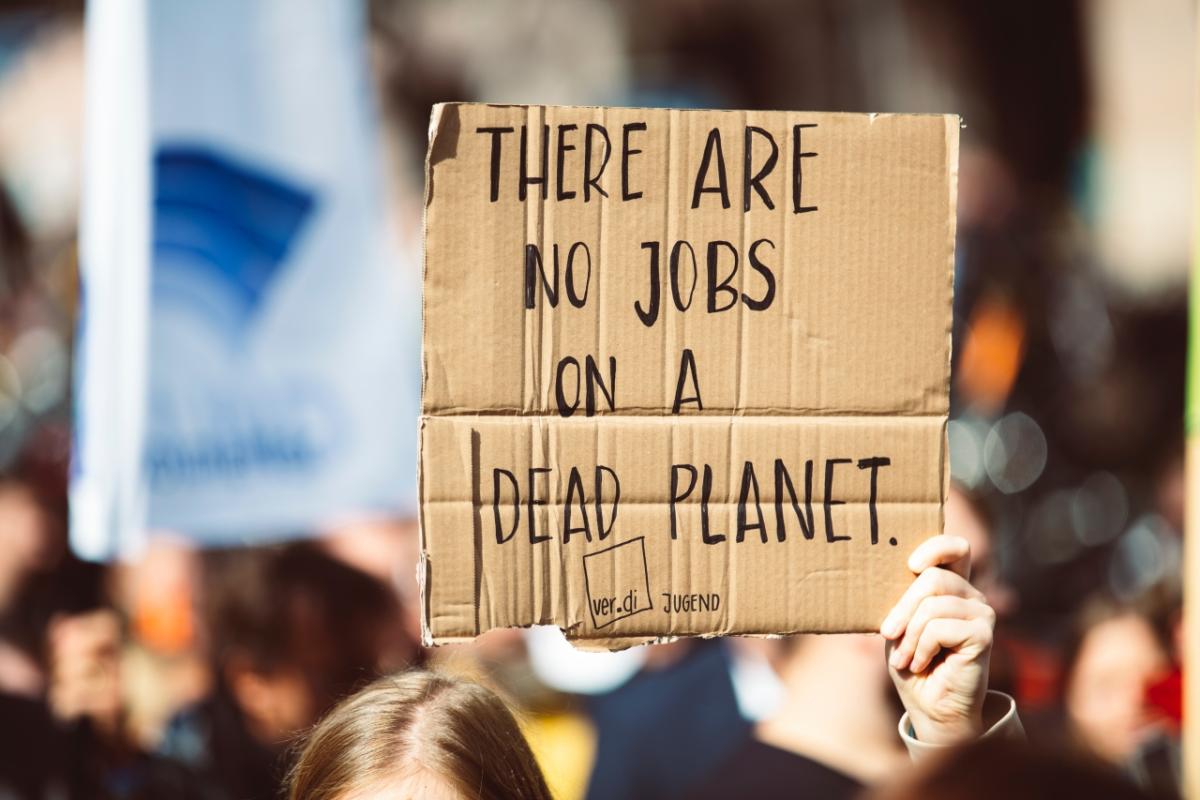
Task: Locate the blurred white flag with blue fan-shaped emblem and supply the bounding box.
[71,0,420,558]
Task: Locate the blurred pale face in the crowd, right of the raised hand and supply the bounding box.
[1063,599,1170,763]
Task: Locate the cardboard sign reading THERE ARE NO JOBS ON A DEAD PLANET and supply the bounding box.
[420,104,959,643]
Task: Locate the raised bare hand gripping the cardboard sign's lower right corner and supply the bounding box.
[880,536,996,745]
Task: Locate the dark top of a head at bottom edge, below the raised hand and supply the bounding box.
[865,738,1146,800]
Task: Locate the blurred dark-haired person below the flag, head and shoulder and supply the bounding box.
[154,542,416,800]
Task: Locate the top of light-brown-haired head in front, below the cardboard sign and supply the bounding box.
[288,670,551,800]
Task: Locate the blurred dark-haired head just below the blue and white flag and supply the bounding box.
[206,542,398,744]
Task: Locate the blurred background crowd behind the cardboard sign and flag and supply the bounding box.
[0,0,1195,800]
